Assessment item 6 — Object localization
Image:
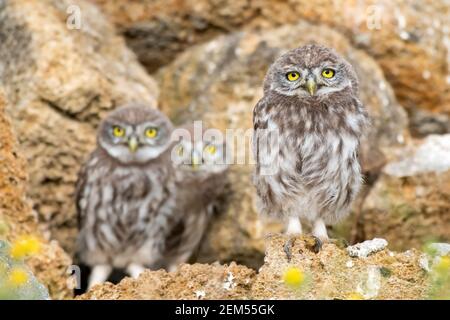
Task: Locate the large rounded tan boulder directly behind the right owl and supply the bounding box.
[157,23,406,268]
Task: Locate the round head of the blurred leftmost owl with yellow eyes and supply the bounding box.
[97,104,173,164]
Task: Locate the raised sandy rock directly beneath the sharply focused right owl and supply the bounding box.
[252,235,428,299]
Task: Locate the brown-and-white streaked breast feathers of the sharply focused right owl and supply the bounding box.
[253,92,368,221]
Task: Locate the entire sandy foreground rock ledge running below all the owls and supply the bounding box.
[78,235,431,300]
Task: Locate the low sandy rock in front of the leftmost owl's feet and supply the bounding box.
[79,263,255,300]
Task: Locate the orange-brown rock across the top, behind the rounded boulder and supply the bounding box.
[91,0,450,118]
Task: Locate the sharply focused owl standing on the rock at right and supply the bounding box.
[253,44,369,245]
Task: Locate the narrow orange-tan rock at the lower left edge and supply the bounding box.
[0,90,72,299]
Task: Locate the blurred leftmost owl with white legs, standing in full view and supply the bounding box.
[76,104,176,287]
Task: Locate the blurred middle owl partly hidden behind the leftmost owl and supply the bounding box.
[158,125,229,271]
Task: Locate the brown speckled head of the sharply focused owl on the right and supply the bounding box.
[264,44,358,99]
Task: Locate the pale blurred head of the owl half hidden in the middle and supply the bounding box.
[172,125,228,173]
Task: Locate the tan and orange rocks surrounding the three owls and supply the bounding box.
[0,0,450,299]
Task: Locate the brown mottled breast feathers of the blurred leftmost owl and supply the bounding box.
[76,150,175,259]
